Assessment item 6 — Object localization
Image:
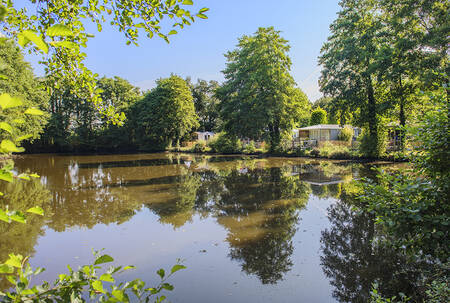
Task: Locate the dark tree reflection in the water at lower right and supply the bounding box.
[321,184,428,302]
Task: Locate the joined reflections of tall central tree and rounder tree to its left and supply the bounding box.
[146,163,310,284]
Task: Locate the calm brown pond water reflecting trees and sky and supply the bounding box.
[0,153,420,303]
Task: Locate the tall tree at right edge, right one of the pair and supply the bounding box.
[377,0,450,147]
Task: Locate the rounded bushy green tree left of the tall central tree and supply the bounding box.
[130,75,199,148]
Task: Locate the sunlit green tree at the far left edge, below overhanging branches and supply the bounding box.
[0,38,49,140]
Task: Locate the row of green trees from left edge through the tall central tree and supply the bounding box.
[1,27,311,152]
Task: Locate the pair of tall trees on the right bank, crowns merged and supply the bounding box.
[319,0,449,156]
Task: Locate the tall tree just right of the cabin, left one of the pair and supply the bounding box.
[319,0,381,156]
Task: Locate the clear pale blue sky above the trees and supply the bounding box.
[32,0,339,101]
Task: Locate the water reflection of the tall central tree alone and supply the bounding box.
[216,167,310,284]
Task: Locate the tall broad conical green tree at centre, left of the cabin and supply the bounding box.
[217,27,309,151]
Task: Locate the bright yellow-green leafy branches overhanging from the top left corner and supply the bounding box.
[0,0,208,123]
